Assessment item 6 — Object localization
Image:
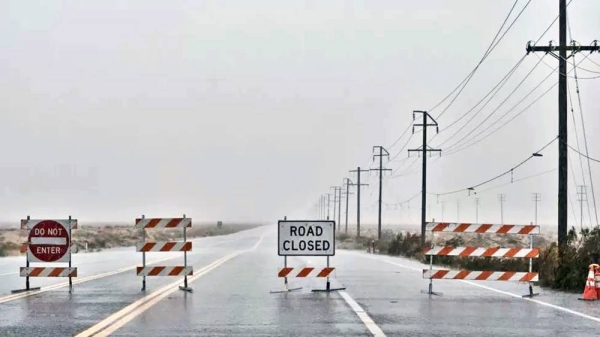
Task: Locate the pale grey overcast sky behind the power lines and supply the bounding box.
[0,0,600,224]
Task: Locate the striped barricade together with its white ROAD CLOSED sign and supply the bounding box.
[271,217,346,293]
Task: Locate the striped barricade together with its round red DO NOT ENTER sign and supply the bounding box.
[12,216,77,293]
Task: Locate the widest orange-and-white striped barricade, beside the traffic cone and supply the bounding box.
[422,222,540,297]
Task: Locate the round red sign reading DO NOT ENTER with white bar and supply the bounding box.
[27,220,71,262]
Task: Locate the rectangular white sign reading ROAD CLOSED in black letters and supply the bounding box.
[278,220,335,256]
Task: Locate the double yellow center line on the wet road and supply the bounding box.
[76,236,263,337]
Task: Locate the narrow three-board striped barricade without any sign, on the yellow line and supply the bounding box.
[135,214,194,292]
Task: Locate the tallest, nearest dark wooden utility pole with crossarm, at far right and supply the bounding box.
[527,0,600,253]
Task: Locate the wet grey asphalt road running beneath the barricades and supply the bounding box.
[0,226,600,336]
